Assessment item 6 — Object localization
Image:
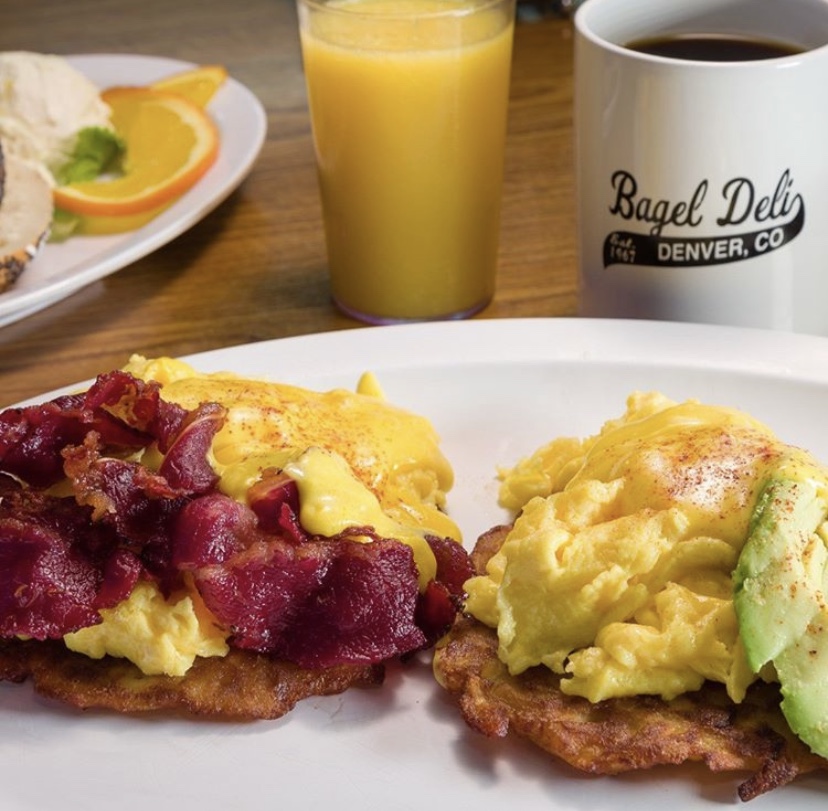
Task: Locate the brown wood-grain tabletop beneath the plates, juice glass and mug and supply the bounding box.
[0,0,577,406]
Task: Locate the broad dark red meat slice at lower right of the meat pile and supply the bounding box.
[195,538,426,668]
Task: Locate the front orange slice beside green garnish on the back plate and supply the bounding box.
[54,87,219,217]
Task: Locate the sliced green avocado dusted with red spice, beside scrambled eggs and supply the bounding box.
[733,478,828,757]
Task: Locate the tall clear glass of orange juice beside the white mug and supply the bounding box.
[297,0,515,324]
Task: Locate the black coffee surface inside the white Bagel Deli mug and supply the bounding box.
[627,34,805,62]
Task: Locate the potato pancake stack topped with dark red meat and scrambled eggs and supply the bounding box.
[0,356,471,718]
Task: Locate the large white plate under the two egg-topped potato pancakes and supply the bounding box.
[0,319,828,811]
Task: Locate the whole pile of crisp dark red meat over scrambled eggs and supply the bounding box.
[0,372,471,668]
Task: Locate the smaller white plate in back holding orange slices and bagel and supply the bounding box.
[0,54,267,326]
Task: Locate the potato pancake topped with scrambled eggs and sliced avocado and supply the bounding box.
[434,394,828,800]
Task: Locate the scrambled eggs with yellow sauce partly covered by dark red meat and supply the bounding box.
[64,356,461,676]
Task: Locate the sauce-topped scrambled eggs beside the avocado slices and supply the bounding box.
[466,393,821,702]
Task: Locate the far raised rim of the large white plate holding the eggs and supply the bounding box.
[14,316,828,410]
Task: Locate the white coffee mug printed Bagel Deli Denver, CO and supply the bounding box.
[575,0,828,334]
